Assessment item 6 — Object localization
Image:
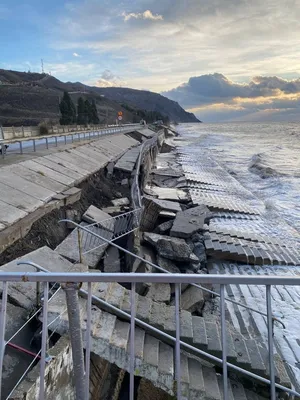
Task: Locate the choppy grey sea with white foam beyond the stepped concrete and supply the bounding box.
[176,123,300,232]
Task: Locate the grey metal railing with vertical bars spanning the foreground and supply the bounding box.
[0,270,300,400]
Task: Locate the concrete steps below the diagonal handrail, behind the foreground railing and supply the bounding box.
[49,293,269,400]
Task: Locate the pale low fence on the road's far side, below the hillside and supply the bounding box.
[0,124,137,140]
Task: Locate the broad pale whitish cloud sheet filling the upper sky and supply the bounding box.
[52,0,300,92]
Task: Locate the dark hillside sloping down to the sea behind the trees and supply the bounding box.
[0,69,199,126]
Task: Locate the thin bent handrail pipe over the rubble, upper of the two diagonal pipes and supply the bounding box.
[59,219,285,328]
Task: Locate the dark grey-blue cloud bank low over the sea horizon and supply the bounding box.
[162,73,300,121]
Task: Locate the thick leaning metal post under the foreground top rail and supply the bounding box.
[62,283,85,400]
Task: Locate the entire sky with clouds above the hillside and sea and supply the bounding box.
[0,0,300,122]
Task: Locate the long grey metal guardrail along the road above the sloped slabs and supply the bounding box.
[0,124,138,158]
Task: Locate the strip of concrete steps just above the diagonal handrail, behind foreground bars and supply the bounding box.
[82,283,289,386]
